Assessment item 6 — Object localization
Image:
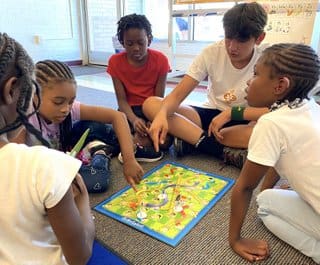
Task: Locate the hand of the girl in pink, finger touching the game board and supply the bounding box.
[123,159,144,191]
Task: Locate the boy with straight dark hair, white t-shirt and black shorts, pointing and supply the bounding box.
[143,3,267,165]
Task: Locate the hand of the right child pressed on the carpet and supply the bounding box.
[232,238,270,262]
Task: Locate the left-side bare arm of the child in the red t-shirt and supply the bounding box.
[112,77,147,135]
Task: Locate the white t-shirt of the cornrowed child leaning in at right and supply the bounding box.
[248,99,320,214]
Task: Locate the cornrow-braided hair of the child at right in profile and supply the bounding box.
[259,43,320,102]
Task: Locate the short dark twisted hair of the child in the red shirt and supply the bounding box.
[117,14,153,45]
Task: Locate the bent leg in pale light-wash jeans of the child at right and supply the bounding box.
[257,189,320,263]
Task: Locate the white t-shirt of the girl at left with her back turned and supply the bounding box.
[0,143,81,265]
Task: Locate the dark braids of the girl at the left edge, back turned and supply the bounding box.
[0,33,49,146]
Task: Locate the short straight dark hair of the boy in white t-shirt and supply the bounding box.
[222,2,268,42]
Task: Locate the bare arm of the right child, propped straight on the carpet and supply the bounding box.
[229,160,269,262]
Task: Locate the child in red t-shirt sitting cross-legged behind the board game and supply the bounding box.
[107,14,170,162]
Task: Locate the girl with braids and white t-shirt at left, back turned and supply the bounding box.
[0,33,95,265]
